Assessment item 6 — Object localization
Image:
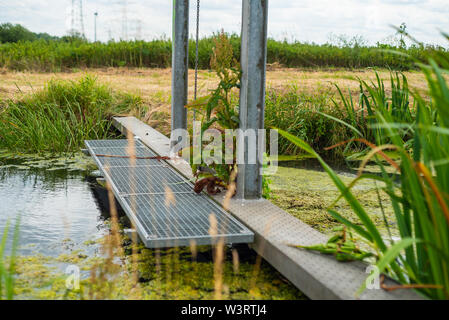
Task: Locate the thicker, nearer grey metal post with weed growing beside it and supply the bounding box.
[237,0,268,199]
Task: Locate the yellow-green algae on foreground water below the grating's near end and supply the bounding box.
[15,240,305,300]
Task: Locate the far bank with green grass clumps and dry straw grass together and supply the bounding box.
[0,69,419,160]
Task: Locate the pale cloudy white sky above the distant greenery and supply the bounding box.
[0,0,449,46]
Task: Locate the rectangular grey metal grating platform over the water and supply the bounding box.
[85,140,254,248]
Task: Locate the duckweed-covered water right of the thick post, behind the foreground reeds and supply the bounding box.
[271,167,396,234]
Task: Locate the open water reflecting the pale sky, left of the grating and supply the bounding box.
[0,161,107,256]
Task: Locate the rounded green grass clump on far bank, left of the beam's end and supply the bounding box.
[0,76,142,152]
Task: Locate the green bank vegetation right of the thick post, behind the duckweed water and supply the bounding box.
[265,72,424,161]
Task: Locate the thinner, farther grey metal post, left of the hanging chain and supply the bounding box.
[171,0,189,136]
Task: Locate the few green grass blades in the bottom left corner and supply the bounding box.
[0,219,20,300]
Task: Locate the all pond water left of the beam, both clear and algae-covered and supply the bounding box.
[0,153,305,299]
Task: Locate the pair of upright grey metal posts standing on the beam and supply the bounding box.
[171,0,268,199]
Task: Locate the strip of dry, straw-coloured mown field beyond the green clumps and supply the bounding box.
[0,66,426,134]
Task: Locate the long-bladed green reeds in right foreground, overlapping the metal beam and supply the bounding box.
[281,38,449,299]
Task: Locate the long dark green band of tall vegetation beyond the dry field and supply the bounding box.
[0,35,447,72]
